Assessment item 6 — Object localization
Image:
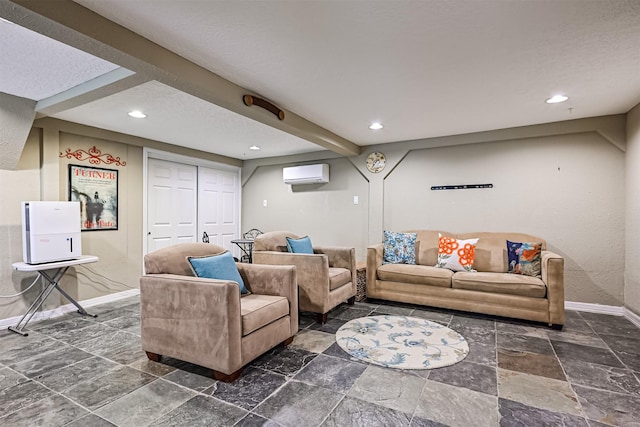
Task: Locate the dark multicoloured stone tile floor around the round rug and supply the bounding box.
[0,297,640,427]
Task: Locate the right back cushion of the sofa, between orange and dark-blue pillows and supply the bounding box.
[454,232,546,273]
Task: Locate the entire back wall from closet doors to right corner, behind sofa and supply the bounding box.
[242,116,625,306]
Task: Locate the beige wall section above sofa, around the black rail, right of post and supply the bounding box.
[384,132,624,306]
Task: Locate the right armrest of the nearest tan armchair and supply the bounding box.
[237,263,298,336]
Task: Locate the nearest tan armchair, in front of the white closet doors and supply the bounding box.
[140,243,298,382]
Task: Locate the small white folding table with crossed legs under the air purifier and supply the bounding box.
[9,255,98,337]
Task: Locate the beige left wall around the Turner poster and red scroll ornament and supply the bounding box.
[0,119,240,319]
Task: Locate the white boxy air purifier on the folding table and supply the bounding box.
[22,202,82,264]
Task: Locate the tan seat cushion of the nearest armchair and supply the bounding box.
[240,294,290,337]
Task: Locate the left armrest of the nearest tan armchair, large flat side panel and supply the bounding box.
[140,274,242,373]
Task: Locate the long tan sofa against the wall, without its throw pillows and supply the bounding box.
[367,230,564,328]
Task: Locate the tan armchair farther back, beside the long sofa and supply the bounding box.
[253,231,356,323]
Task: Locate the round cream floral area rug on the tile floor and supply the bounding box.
[336,316,469,369]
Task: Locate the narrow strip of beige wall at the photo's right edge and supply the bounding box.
[624,104,640,316]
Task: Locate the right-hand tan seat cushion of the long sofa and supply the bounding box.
[451,271,547,298]
